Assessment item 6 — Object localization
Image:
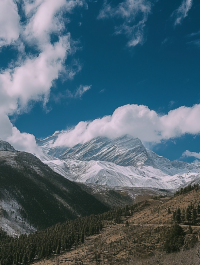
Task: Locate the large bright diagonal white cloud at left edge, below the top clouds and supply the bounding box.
[0,36,70,111]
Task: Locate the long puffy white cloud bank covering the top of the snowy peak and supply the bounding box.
[54,104,200,147]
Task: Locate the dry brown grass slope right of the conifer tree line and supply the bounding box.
[32,191,200,265]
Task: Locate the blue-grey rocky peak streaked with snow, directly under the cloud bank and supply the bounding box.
[37,135,148,166]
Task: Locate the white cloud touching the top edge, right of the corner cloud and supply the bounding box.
[24,0,84,45]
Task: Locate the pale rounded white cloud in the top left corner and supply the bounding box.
[0,0,20,47]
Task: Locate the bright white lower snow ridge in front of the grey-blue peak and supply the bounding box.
[45,160,200,189]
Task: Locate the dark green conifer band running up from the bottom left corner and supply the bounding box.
[0,203,144,265]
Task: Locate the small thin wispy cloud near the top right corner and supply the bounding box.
[172,0,193,26]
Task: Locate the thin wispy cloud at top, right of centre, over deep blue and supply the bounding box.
[98,0,151,47]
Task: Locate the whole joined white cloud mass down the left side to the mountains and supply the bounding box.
[0,0,85,155]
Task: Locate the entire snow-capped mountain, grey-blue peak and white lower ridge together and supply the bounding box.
[38,132,200,189]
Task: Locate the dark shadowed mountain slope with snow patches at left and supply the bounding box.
[0,151,108,234]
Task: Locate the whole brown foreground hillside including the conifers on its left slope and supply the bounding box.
[2,185,200,265]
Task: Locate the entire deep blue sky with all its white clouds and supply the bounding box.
[0,0,200,162]
